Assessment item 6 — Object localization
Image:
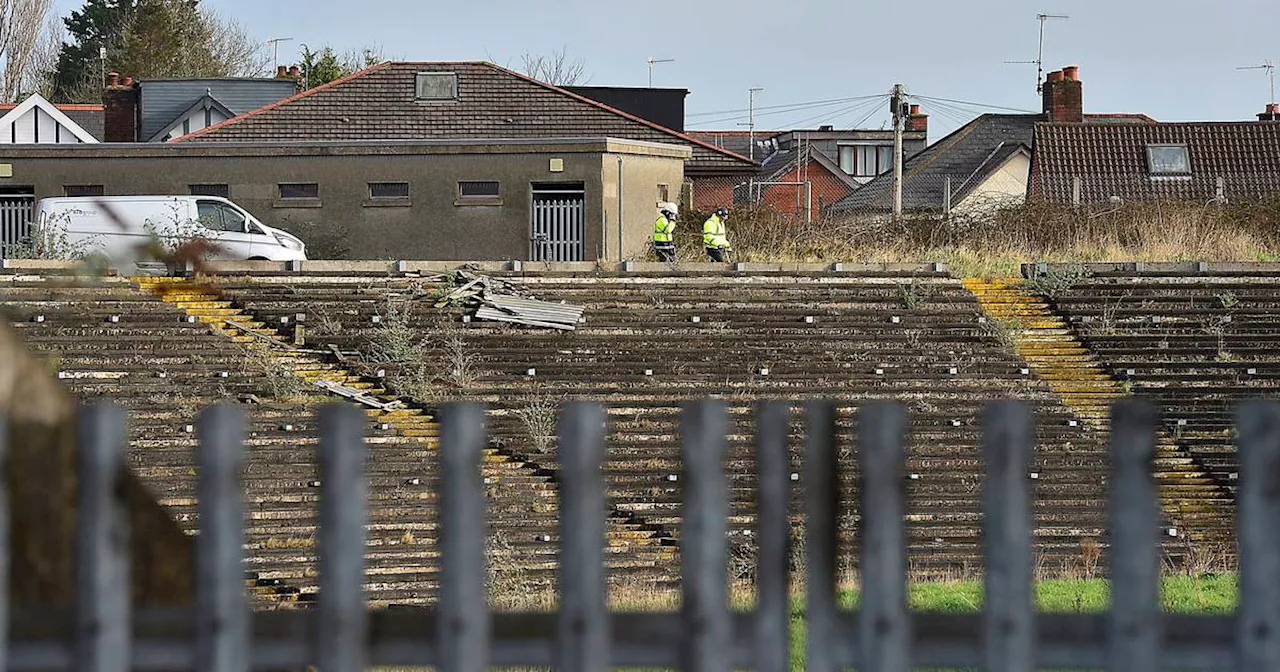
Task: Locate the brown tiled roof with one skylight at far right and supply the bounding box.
[1030,122,1280,202]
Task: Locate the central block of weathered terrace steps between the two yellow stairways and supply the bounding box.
[209,269,1106,573]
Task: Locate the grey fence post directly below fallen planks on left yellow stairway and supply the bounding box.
[316,403,369,672]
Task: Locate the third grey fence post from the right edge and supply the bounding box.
[982,402,1036,672]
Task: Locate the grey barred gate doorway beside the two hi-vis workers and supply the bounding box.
[529,182,586,261]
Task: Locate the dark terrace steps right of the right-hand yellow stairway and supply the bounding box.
[1047,264,1280,552]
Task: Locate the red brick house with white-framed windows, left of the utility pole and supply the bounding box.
[690,116,928,215]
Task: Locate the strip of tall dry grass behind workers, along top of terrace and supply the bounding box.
[677,196,1280,276]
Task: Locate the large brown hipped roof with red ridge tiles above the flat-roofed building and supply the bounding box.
[178,63,758,174]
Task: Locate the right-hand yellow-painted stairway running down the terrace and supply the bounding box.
[965,278,1233,553]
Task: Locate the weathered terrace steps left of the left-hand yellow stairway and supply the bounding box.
[0,269,669,605]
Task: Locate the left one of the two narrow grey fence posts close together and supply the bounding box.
[755,402,791,672]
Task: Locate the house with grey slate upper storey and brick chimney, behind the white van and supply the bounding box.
[102,65,298,142]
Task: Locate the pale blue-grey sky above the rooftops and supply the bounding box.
[49,0,1280,140]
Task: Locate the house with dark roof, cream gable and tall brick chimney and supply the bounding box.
[827,67,1156,216]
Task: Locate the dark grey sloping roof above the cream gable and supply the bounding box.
[831,114,1041,214]
